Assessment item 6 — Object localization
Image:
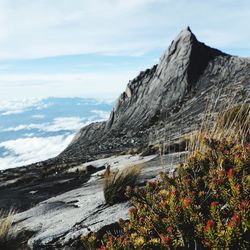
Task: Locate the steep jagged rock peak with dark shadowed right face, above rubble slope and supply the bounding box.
[106,27,226,133]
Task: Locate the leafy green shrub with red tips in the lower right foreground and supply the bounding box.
[84,138,250,250]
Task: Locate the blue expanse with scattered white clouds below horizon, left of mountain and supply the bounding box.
[0,98,113,170]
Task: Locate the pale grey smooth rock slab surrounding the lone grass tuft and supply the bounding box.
[14,153,185,250]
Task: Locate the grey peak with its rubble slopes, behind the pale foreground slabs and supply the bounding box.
[55,27,250,162]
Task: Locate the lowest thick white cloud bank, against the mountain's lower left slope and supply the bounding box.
[0,134,74,169]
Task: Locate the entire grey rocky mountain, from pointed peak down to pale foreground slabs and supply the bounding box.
[0,28,250,249]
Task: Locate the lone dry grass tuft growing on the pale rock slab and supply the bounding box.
[103,165,142,205]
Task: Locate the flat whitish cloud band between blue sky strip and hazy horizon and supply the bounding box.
[0,72,138,99]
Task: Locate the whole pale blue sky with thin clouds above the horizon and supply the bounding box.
[0,0,250,100]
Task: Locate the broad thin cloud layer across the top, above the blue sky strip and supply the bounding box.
[0,0,250,59]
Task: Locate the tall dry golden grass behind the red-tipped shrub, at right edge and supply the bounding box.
[186,86,250,155]
